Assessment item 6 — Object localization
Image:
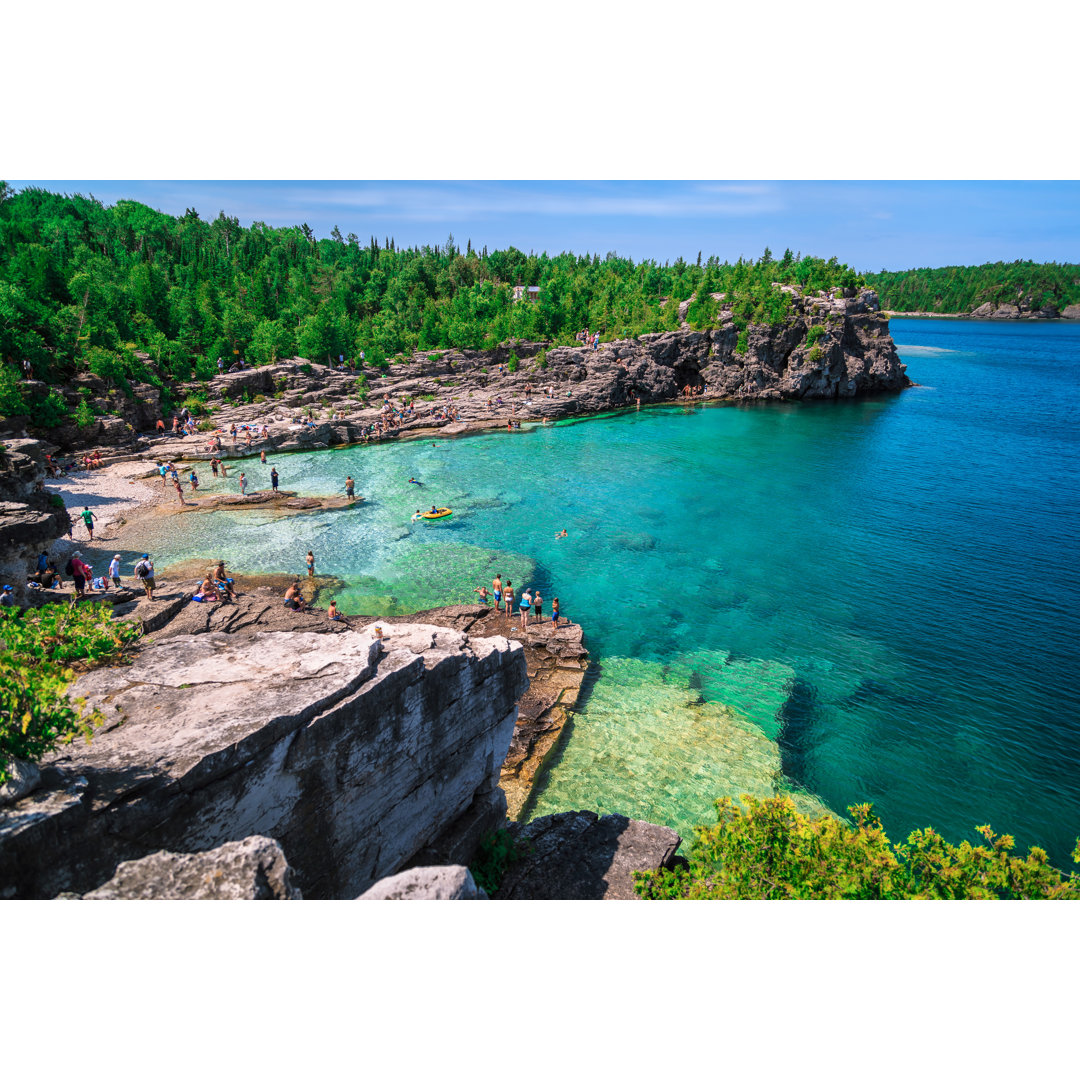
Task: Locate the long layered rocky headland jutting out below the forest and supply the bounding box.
[16,285,912,462]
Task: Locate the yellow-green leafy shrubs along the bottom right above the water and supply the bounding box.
[634,795,1080,900]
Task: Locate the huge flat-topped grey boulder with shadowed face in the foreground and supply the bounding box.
[0,624,527,899]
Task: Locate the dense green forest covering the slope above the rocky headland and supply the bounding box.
[0,181,862,427]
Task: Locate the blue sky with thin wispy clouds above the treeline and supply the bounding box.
[11,180,1080,270]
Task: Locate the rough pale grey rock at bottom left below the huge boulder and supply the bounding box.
[82,836,302,900]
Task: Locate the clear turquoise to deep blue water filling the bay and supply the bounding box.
[145,320,1080,866]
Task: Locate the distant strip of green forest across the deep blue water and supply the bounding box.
[866,260,1080,314]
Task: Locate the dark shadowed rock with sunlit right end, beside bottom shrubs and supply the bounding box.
[496,810,681,900]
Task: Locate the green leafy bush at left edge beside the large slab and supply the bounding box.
[0,604,140,784]
